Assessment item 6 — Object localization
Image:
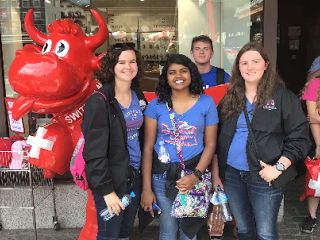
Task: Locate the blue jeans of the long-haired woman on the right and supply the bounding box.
[224,166,283,240]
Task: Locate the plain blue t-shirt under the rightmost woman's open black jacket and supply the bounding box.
[227,100,255,171]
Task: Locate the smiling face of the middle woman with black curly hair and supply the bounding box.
[167,63,191,91]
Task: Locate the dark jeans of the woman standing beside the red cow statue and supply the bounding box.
[93,172,141,240]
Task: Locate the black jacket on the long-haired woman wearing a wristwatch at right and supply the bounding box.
[217,87,310,180]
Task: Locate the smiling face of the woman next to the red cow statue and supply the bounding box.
[114,50,138,82]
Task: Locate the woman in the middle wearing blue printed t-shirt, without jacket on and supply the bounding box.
[141,54,218,240]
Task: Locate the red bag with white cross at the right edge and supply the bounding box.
[300,157,320,201]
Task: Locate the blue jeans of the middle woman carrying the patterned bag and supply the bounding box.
[152,174,197,240]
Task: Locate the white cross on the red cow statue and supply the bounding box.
[27,127,53,159]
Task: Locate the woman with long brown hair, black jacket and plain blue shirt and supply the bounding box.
[213,42,309,240]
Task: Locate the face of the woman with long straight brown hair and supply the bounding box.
[239,50,268,84]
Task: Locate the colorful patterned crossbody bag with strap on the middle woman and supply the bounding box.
[167,104,211,218]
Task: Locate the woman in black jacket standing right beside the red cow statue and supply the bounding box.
[81,45,146,240]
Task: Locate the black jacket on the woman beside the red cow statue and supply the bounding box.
[81,83,147,197]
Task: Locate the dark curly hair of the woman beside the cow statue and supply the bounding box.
[96,44,143,88]
